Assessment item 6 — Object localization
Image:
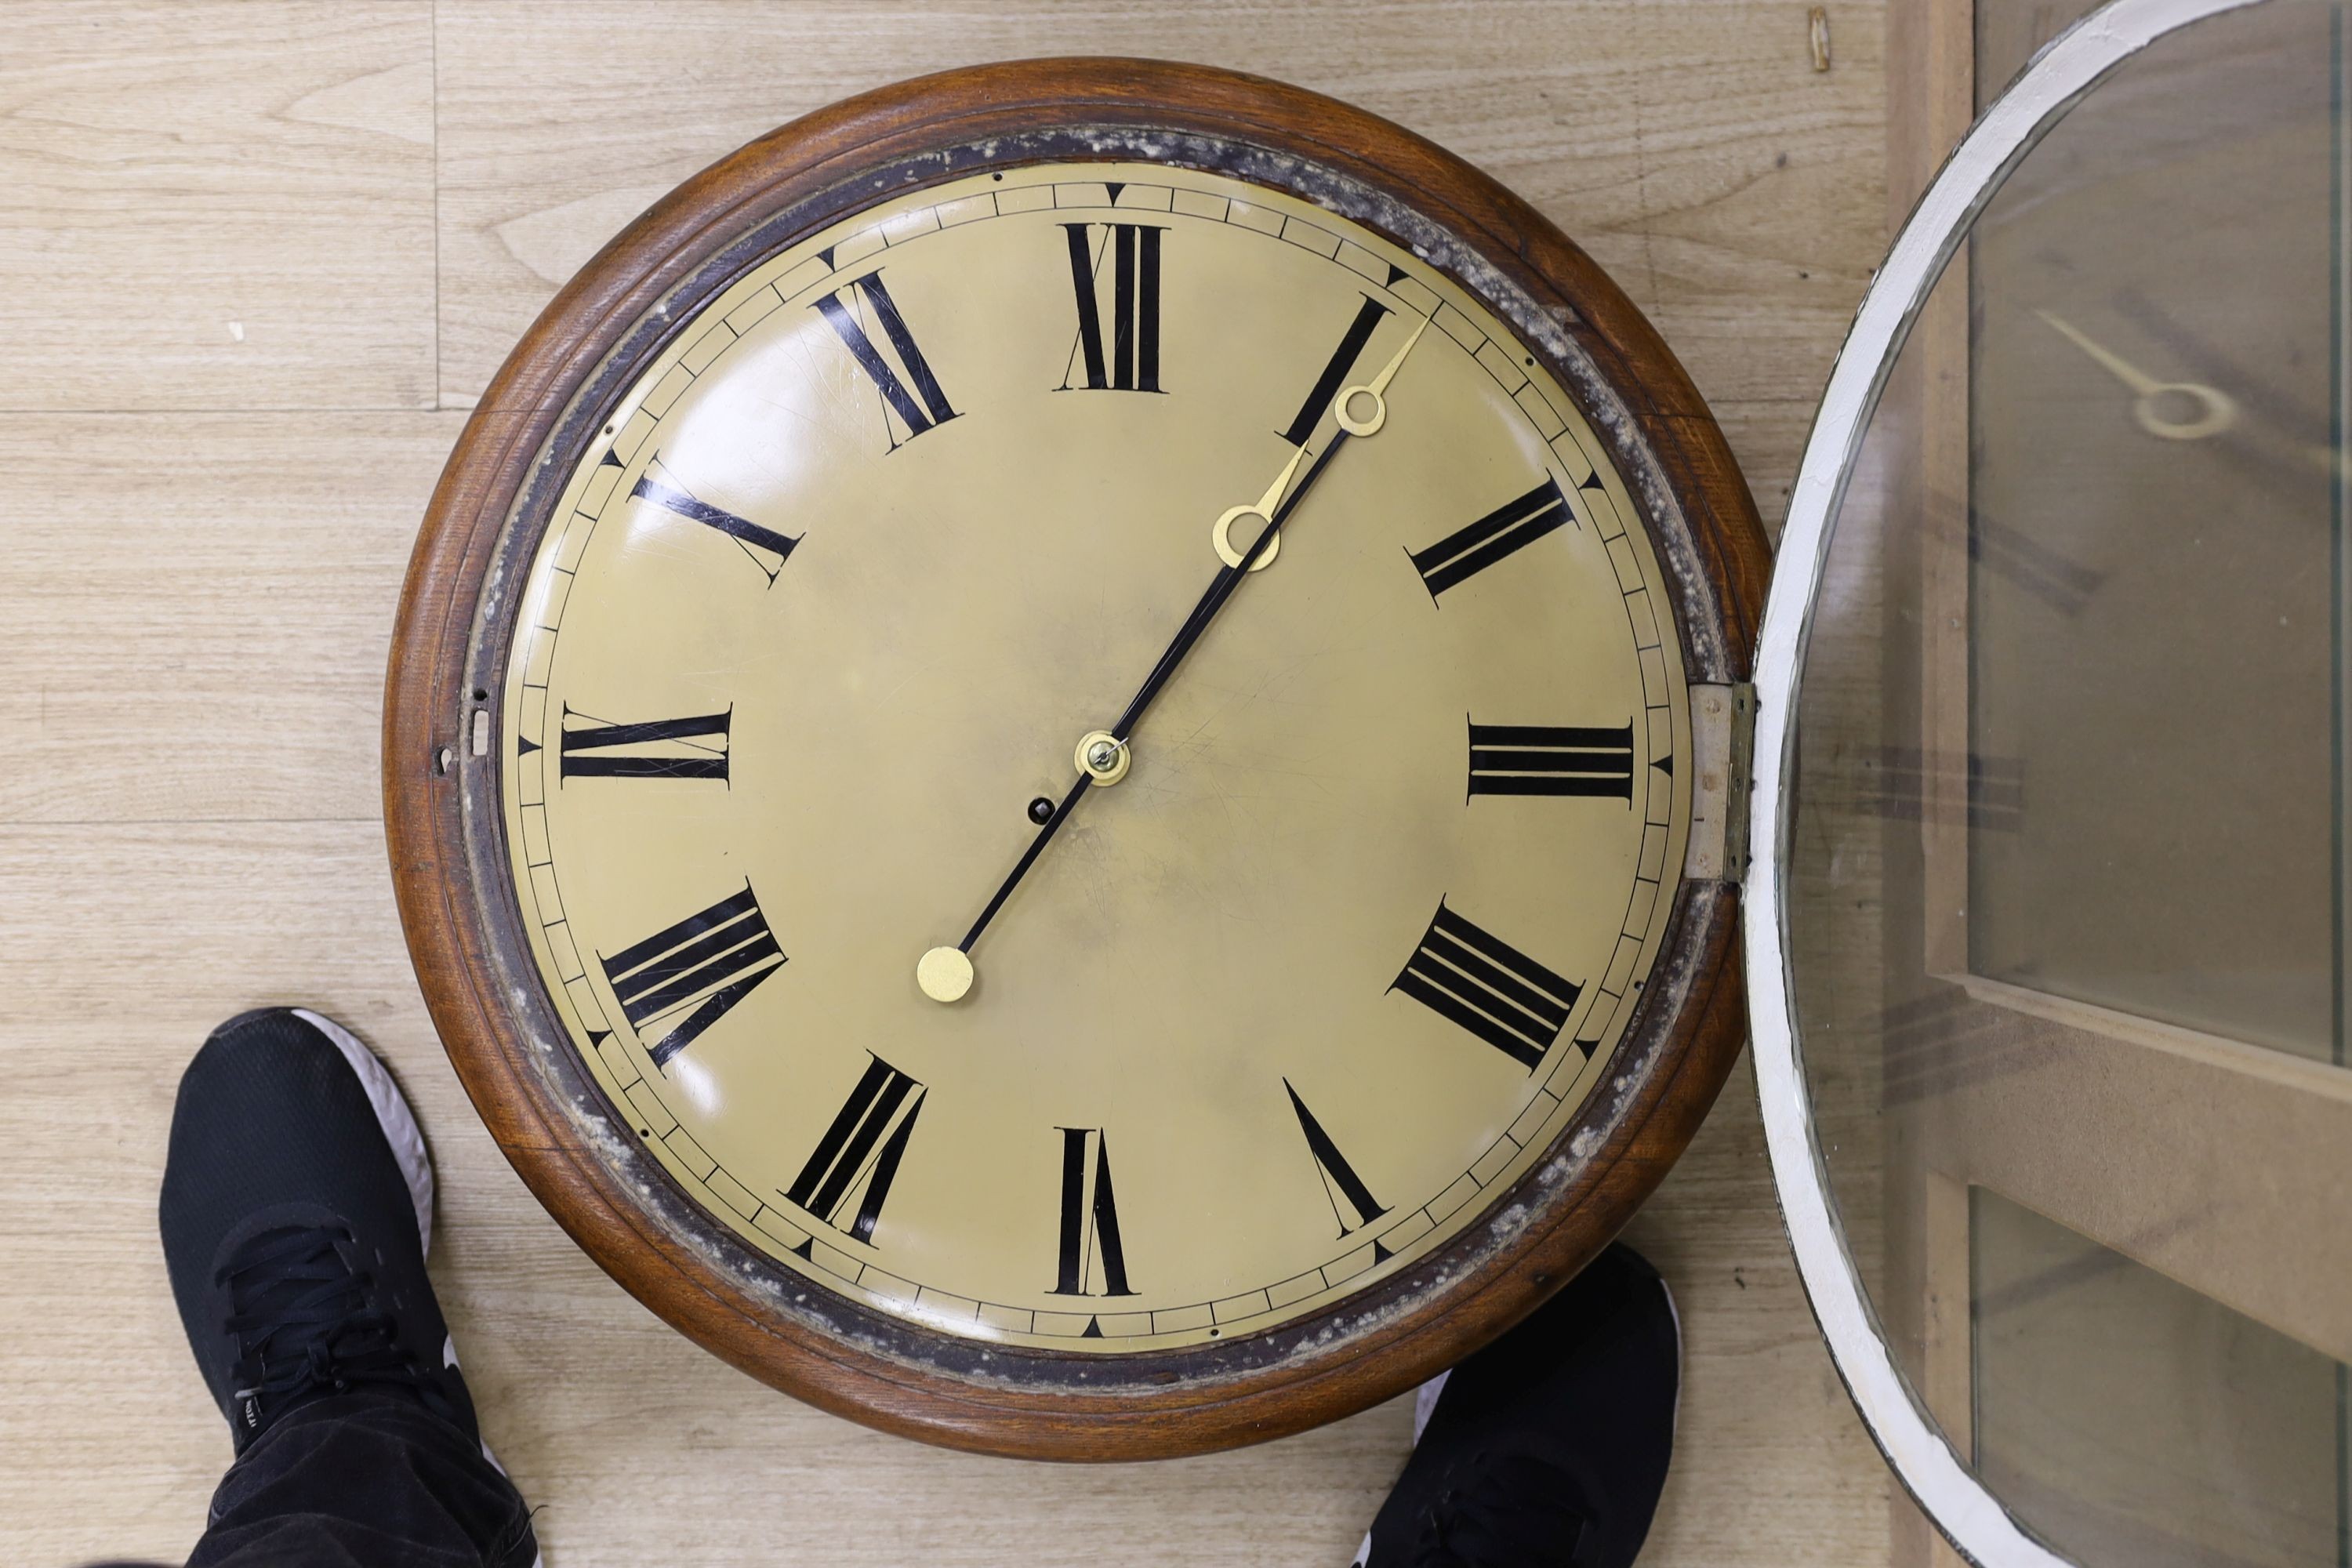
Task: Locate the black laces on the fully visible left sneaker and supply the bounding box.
[221,1225,423,1432]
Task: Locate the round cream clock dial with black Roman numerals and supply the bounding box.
[499,162,1689,1352]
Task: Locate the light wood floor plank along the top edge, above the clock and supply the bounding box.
[440,0,1884,441]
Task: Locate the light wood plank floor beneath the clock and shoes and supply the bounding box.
[0,0,1898,1568]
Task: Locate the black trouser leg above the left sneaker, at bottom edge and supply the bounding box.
[188,1394,539,1568]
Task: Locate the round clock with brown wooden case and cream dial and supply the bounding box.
[383,61,1766,1460]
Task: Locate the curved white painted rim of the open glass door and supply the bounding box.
[1743,0,2263,1568]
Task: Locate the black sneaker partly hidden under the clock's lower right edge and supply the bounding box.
[1355,1243,1682,1568]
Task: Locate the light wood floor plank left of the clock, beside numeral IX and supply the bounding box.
[0,414,463,822]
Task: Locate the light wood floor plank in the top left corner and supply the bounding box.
[0,0,435,409]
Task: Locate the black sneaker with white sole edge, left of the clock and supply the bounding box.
[160,1008,480,1453]
